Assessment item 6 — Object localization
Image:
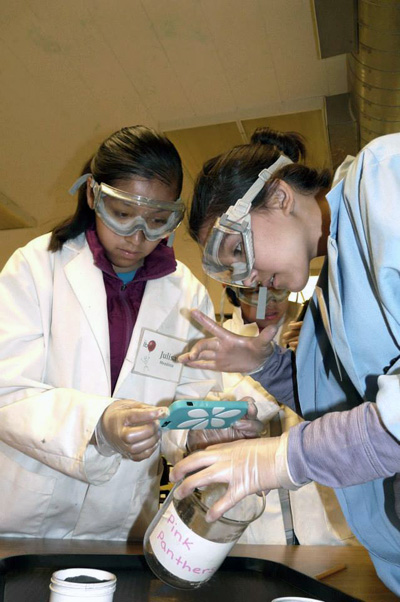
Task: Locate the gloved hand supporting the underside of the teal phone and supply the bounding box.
[186,397,264,452]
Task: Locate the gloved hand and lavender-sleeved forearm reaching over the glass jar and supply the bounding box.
[170,403,400,521]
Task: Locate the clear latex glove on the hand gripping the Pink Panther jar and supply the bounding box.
[170,433,298,522]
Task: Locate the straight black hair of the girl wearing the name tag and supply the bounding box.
[49,125,183,252]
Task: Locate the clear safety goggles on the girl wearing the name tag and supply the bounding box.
[70,174,185,241]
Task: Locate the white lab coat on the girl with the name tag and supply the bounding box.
[0,235,219,539]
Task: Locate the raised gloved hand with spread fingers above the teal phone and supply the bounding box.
[178,309,277,373]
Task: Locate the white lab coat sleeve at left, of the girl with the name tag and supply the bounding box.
[0,250,159,484]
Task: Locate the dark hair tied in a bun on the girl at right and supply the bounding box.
[188,127,332,241]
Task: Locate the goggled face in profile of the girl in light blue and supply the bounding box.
[200,155,314,292]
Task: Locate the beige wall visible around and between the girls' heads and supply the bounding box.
[0,110,330,313]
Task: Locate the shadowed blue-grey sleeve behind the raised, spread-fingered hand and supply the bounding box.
[251,345,297,412]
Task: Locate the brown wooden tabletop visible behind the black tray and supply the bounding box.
[0,538,399,602]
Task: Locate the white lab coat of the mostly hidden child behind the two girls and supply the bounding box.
[223,303,358,545]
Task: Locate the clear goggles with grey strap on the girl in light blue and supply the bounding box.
[203,155,292,286]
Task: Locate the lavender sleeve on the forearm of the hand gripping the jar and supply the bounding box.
[288,402,400,488]
